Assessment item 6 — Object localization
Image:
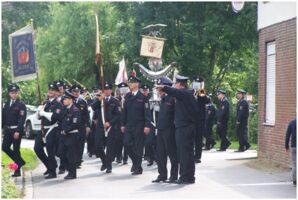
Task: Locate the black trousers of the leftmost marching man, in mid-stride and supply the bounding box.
[2,129,25,166]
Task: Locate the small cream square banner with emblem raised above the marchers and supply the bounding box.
[141,36,165,58]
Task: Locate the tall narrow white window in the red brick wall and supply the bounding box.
[265,41,276,125]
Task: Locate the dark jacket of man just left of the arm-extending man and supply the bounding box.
[157,95,175,130]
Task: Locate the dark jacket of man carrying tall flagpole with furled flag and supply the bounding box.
[91,96,121,127]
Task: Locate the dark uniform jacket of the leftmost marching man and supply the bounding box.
[2,99,27,132]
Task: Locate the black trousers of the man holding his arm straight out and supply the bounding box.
[175,125,196,181]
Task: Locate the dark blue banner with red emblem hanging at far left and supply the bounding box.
[9,24,37,82]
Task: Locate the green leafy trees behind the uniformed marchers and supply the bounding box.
[2,2,258,140]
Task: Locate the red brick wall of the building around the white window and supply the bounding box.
[258,18,296,165]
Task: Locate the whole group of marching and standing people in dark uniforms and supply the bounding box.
[2,75,250,184]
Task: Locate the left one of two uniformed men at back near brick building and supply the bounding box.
[216,89,231,151]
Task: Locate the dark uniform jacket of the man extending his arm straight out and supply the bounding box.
[164,86,198,128]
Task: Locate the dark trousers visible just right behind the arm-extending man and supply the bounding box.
[195,120,205,159]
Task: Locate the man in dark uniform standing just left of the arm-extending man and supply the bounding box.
[152,77,178,183]
